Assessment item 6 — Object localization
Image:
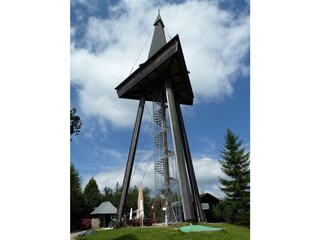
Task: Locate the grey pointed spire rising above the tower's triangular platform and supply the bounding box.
[148,11,166,58]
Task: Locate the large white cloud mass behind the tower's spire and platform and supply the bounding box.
[71,0,249,127]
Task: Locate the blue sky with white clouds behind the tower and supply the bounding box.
[70,0,250,197]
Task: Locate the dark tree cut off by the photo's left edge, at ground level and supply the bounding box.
[70,163,84,228]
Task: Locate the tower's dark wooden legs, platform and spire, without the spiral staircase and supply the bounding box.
[116,13,205,222]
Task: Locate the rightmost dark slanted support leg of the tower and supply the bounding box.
[176,104,205,222]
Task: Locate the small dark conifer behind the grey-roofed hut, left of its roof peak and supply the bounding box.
[83,178,102,217]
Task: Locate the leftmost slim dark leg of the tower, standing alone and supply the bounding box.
[117,97,145,225]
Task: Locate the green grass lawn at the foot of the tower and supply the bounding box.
[77,223,250,240]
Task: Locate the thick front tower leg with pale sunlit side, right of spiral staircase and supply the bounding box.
[165,79,195,221]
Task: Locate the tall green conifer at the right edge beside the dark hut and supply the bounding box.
[219,129,250,225]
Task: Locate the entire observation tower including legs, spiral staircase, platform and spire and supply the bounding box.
[116,12,205,222]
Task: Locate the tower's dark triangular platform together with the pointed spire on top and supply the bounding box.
[116,13,194,105]
